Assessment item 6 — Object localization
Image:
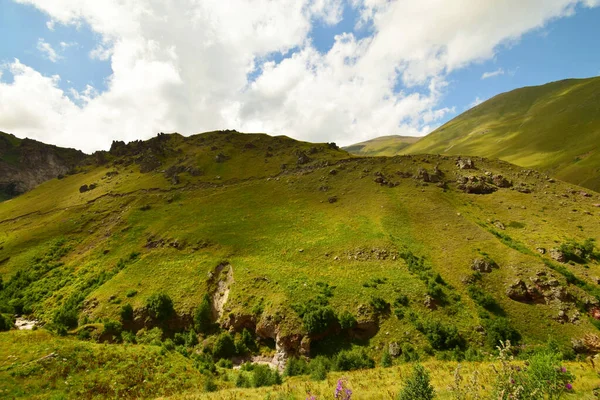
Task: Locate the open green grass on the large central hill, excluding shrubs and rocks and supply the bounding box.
[0,133,600,396]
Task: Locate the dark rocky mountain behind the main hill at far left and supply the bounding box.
[0,132,86,201]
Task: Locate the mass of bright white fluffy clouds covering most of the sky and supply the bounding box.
[0,0,598,151]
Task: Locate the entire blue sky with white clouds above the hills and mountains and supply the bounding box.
[0,0,600,153]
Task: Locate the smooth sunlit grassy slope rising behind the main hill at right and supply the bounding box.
[406,78,600,190]
